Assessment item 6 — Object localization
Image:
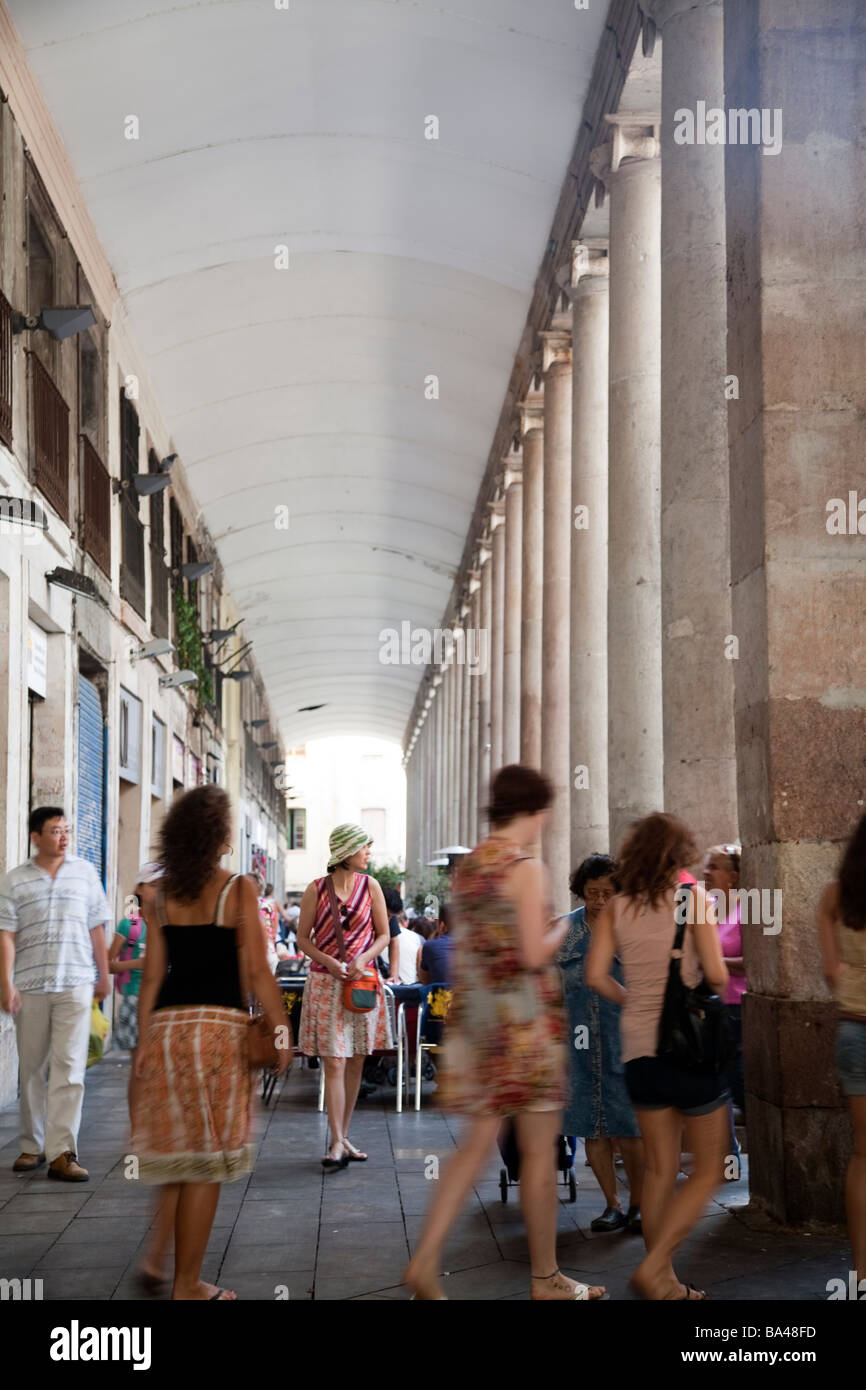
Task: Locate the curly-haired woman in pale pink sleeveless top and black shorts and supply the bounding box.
[587,812,728,1301]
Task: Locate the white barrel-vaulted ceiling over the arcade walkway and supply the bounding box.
[7,0,606,742]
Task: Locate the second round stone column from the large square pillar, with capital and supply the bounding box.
[591,115,664,853]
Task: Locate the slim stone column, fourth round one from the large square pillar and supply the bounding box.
[539,311,571,908]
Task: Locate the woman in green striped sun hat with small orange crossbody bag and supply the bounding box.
[297,826,392,1173]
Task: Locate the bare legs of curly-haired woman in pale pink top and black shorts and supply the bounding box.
[634,1105,730,1298]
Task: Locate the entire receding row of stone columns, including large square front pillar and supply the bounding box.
[407,0,866,1220]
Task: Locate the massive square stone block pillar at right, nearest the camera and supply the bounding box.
[724,0,866,1223]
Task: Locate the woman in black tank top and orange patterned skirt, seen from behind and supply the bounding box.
[133,785,292,1301]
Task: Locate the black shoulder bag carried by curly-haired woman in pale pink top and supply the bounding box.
[656,895,731,1074]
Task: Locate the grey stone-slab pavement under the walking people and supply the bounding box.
[0,1054,849,1301]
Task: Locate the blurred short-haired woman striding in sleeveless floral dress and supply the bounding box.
[406,765,605,1302]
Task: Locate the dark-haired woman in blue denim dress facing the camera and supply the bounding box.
[556,855,644,1234]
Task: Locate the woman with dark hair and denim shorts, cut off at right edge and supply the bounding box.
[817,816,866,1282]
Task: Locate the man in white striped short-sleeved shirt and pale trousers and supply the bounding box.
[0,806,111,1183]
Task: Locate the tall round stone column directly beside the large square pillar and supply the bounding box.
[644,0,737,849]
